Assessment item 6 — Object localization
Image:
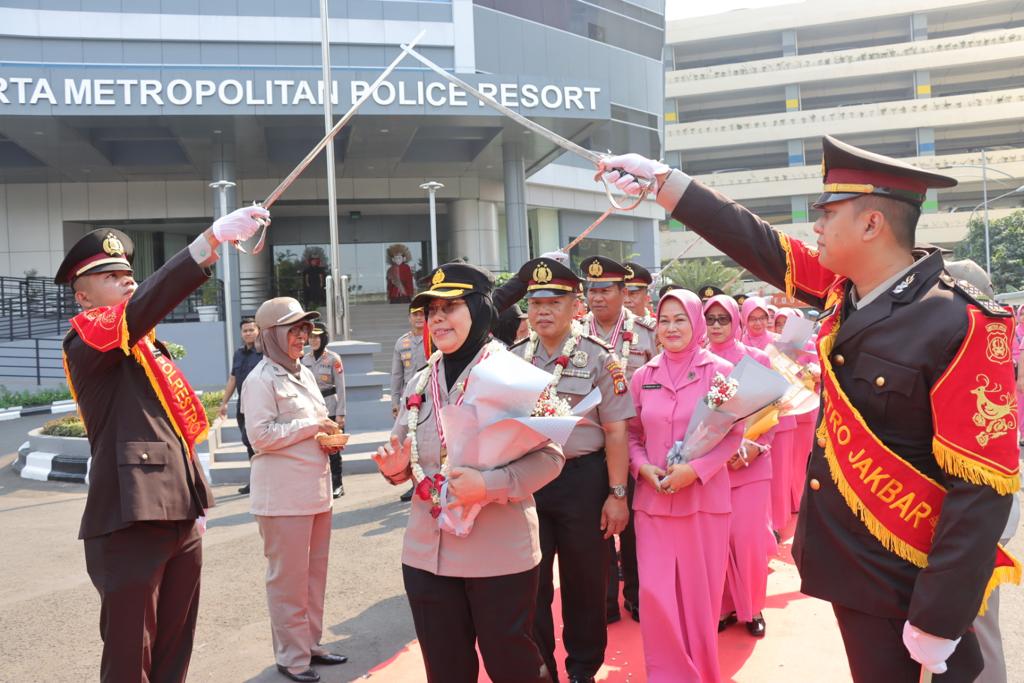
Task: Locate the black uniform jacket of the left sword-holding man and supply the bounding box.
[63,249,213,539]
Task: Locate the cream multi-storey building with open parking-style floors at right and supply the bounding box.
[662,0,1024,272]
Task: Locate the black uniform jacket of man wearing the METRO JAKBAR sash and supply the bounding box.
[667,176,1012,638]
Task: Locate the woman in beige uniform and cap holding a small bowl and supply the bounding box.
[242,297,347,681]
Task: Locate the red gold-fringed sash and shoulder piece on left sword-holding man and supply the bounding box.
[63,301,210,457]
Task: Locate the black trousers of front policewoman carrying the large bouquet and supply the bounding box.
[401,564,551,683]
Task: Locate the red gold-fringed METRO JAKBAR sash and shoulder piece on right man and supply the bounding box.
[817,283,1021,614]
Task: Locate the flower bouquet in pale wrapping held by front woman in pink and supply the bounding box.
[666,356,790,466]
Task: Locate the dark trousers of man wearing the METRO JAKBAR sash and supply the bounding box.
[833,604,985,683]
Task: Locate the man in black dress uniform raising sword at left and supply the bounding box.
[54,207,270,683]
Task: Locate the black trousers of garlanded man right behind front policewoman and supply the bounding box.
[534,451,608,680]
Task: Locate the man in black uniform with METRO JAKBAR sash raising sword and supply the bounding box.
[605,137,1021,683]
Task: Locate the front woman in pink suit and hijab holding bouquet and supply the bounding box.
[630,290,742,683]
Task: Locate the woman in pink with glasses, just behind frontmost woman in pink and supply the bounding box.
[705,294,774,638]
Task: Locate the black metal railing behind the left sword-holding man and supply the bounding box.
[0,276,224,342]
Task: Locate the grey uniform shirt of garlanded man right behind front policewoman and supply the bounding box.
[510,335,636,459]
